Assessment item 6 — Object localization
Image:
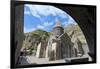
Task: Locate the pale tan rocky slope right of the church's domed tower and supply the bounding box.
[64,24,86,44]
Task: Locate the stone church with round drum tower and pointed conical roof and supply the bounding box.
[36,22,83,61]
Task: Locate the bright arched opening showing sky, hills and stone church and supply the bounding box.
[17,5,92,64]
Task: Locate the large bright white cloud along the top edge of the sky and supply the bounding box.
[25,4,66,18]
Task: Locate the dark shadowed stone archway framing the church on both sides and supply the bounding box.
[11,2,96,64]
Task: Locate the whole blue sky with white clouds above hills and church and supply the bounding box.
[24,4,76,33]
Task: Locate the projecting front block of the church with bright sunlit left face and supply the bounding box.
[49,39,61,60]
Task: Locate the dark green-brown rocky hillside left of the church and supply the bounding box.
[21,30,50,55]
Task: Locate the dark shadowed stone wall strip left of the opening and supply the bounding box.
[13,5,24,64]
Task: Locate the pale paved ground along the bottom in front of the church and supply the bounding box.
[20,45,92,65]
